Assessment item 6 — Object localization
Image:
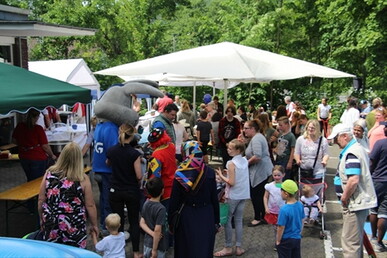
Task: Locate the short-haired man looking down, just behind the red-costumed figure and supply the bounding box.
[152,103,179,144]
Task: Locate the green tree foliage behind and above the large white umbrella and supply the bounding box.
[1,0,387,112]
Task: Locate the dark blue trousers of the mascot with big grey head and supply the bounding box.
[94,172,112,229]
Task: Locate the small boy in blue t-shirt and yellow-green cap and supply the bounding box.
[276,179,305,258]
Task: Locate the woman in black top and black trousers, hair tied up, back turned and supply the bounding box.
[106,124,142,257]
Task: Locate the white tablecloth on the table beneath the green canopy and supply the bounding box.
[46,124,87,148]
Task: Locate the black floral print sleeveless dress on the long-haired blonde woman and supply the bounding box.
[42,172,87,248]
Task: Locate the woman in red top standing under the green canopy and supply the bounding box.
[12,109,56,181]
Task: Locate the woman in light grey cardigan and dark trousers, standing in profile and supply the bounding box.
[243,120,273,227]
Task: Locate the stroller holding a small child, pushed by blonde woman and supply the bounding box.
[298,169,328,239]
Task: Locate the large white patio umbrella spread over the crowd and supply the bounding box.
[96,42,355,108]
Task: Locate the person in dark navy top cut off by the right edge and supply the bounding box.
[370,122,387,252]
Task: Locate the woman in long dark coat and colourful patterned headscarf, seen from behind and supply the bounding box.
[168,141,219,258]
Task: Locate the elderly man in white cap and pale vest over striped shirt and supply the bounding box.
[328,124,377,258]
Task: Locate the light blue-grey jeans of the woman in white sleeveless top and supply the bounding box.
[225,199,246,247]
